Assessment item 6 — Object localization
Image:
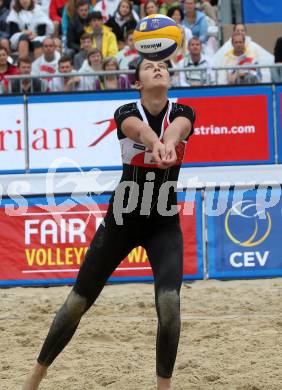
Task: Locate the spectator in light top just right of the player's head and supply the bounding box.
[179,37,213,87]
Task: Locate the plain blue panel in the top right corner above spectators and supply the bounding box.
[243,0,282,24]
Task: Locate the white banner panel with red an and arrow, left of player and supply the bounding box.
[28,98,129,170]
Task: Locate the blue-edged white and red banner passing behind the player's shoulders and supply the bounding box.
[25,86,275,171]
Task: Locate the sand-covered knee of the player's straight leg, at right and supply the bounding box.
[157,290,180,328]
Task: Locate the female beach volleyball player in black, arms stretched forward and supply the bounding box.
[23,59,195,390]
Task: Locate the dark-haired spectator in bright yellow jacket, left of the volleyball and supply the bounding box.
[85,11,118,57]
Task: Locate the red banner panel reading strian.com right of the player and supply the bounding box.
[178,95,270,163]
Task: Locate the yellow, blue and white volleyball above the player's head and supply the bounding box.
[133,14,182,61]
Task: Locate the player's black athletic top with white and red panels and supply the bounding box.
[110,100,195,218]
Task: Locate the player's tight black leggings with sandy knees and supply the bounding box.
[38,214,183,378]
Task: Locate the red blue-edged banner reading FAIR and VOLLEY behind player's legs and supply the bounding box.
[0,193,203,286]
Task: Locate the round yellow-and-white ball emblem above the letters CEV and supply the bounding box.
[224,200,272,247]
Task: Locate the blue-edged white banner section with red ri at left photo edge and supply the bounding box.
[0,96,25,173]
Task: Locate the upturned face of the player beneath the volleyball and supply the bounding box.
[139,60,170,89]
